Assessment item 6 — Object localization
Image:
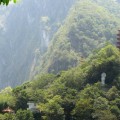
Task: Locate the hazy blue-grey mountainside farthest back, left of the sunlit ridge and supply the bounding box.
[0,0,74,87]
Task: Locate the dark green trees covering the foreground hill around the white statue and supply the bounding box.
[0,44,120,120]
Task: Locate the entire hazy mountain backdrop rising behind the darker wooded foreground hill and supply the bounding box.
[0,0,120,88]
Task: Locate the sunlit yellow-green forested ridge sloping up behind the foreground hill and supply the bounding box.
[38,0,120,73]
